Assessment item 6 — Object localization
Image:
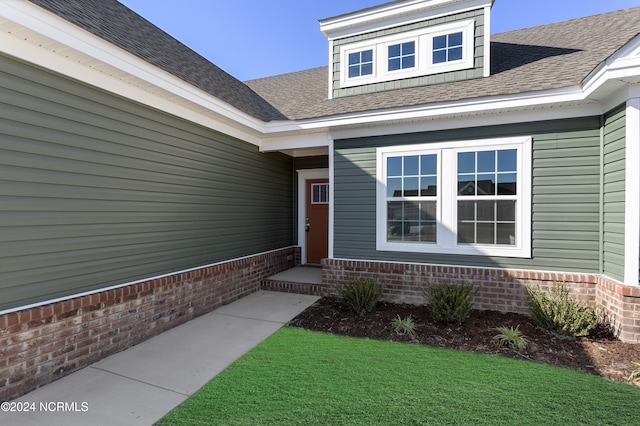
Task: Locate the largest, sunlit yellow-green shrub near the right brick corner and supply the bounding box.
[527,283,602,336]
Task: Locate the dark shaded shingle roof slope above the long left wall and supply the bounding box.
[29,0,285,121]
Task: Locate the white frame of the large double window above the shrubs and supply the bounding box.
[376,136,532,258]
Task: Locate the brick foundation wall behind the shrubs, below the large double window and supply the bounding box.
[322,259,640,343]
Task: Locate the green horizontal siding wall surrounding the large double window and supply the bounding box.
[334,117,600,272]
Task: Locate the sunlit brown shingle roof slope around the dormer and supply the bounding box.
[247,7,640,120]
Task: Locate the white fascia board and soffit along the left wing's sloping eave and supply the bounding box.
[0,1,264,145]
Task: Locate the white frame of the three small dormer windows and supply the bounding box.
[340,19,475,88]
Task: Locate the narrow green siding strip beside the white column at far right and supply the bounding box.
[603,107,626,281]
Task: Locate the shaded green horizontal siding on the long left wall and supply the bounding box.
[0,57,293,309]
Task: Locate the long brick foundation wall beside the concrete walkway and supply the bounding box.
[0,248,299,401]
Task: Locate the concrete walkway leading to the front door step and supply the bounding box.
[0,291,318,426]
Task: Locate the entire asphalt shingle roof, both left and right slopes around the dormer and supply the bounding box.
[30,0,640,121]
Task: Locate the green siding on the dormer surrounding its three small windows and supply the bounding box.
[333,9,484,98]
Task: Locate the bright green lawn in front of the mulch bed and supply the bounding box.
[159,327,640,426]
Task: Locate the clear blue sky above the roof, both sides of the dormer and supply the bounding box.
[119,0,640,81]
